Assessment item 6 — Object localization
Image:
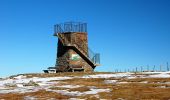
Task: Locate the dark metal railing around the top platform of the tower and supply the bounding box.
[54,22,87,35]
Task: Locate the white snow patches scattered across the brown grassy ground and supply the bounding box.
[0,72,170,96]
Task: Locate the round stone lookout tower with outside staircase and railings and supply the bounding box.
[44,22,100,72]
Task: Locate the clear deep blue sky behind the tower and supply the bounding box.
[0,0,170,77]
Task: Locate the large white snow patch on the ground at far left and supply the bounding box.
[0,76,72,93]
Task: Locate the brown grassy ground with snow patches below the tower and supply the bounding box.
[0,72,170,100]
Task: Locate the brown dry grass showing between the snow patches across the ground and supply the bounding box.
[0,73,170,100]
